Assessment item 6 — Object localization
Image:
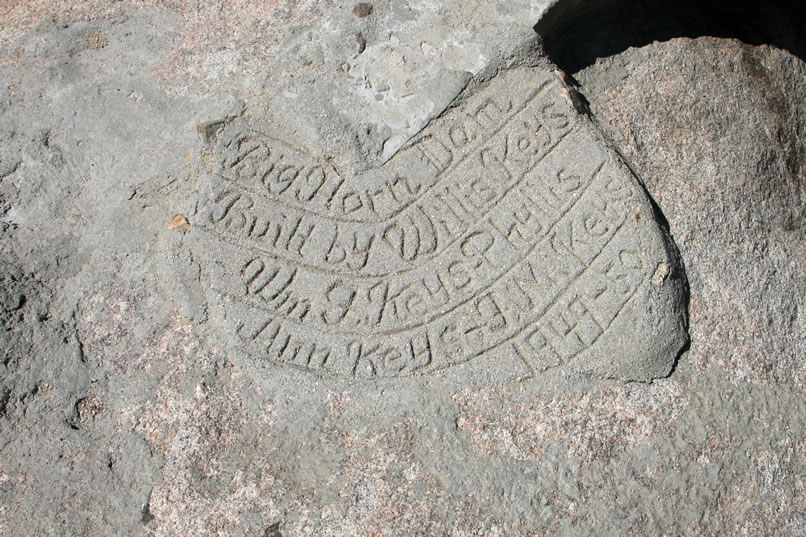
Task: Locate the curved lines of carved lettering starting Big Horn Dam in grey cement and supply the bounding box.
[192,69,672,378]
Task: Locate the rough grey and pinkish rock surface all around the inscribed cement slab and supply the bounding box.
[0,0,806,537]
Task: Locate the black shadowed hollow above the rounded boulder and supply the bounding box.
[534,0,806,73]
